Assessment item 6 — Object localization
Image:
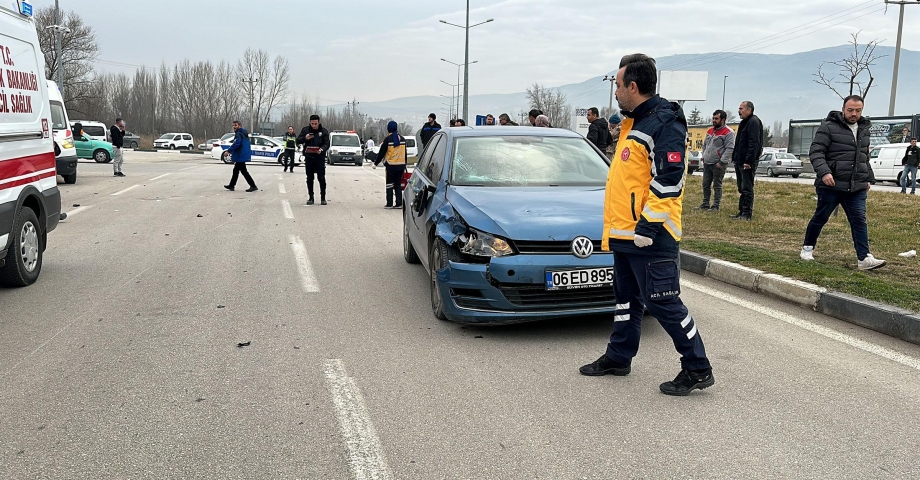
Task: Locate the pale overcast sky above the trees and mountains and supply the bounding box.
[32,0,920,104]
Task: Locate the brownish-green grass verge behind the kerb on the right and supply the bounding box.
[681,177,920,311]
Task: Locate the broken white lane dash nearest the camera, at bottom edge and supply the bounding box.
[324,359,393,480]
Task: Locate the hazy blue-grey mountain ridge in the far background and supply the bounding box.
[337,45,920,128]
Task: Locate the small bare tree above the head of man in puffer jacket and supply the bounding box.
[812,32,887,100]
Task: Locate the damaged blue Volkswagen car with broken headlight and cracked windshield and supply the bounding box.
[403,126,616,324]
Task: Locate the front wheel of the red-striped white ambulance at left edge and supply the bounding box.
[0,208,45,287]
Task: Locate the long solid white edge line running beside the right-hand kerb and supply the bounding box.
[680,280,920,370]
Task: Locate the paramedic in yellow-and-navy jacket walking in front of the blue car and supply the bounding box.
[580,54,715,395]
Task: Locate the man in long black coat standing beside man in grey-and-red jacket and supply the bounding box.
[732,100,763,220]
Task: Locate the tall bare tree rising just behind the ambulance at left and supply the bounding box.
[35,6,99,104]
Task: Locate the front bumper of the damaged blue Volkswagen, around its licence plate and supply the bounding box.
[438,253,616,324]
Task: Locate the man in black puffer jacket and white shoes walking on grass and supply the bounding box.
[799,95,886,270]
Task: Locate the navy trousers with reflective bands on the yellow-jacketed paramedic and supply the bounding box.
[606,252,710,370]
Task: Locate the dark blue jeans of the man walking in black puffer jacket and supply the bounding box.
[803,187,869,260]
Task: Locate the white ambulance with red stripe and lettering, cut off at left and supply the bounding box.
[0,1,62,284]
